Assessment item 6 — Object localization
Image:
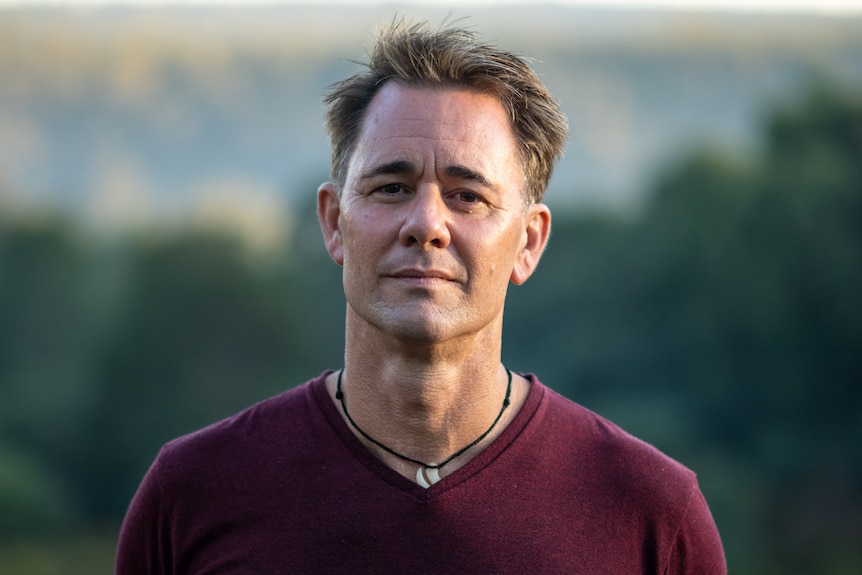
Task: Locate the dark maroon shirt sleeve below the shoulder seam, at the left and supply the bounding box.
[114,458,173,575]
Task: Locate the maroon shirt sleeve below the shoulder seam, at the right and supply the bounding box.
[665,485,727,575]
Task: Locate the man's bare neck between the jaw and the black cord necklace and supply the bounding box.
[344,306,506,440]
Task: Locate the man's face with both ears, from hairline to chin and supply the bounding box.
[318,83,550,343]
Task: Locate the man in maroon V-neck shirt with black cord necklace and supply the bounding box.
[117,22,725,575]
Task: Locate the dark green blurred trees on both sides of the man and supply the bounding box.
[0,85,862,574]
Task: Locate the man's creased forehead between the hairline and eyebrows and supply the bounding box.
[349,82,521,184]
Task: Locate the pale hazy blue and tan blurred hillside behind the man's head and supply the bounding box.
[0,6,862,225]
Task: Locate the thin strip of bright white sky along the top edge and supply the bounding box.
[0,0,862,15]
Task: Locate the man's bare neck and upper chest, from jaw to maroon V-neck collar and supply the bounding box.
[327,308,528,483]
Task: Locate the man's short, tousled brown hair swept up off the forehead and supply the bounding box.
[323,19,568,202]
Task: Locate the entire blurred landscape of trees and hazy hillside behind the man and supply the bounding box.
[0,2,862,575]
